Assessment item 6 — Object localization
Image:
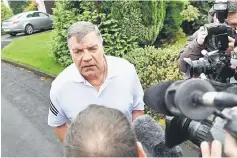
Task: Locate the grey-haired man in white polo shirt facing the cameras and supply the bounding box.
[48,21,144,142]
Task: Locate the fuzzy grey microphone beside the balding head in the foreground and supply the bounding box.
[132,115,183,157]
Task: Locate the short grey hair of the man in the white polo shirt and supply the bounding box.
[67,21,103,46]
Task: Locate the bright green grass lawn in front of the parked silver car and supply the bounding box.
[2,31,64,75]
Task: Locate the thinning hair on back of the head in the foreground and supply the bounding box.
[64,105,138,157]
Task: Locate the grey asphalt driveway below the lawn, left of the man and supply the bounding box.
[1,62,63,157]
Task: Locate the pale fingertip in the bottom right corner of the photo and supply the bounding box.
[224,134,237,157]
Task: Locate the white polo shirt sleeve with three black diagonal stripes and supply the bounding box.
[48,84,68,127]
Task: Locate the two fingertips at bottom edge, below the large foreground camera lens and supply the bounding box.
[201,140,222,158]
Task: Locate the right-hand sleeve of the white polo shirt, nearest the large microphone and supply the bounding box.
[132,63,144,110]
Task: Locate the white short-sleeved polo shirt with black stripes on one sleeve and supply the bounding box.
[48,56,144,127]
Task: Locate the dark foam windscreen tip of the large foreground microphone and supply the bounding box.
[143,81,175,116]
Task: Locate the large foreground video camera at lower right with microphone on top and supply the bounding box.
[144,78,237,156]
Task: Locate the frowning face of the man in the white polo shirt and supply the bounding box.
[68,32,104,79]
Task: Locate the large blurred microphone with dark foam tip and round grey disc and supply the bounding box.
[144,78,237,120]
